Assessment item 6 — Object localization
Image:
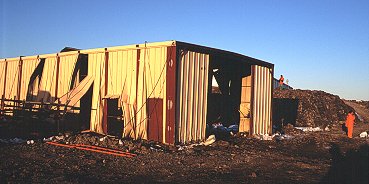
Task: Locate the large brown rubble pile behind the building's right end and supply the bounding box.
[273,89,353,128]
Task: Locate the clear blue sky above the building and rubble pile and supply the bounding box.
[0,0,369,100]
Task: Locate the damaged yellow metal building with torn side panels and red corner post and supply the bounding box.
[0,41,274,144]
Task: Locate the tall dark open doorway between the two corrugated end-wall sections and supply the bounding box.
[207,56,251,138]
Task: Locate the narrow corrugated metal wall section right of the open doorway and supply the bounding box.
[251,65,273,135]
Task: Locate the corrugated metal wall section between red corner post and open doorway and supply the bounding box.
[176,50,209,143]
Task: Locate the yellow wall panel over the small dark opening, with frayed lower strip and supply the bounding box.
[107,49,137,138]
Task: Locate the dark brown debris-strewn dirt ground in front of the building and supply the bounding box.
[0,101,369,183]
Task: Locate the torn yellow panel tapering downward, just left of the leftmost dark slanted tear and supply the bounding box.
[19,56,39,100]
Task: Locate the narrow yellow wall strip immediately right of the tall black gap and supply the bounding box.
[88,52,105,133]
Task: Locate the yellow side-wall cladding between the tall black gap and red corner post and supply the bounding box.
[81,47,167,141]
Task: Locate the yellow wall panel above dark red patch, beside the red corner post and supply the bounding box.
[134,47,167,141]
